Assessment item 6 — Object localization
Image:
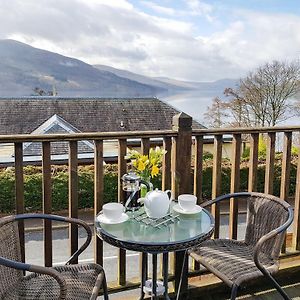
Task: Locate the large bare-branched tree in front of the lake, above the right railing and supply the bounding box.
[209,61,300,126]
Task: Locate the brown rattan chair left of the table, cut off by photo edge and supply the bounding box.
[0,214,108,300]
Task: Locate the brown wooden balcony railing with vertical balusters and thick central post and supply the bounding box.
[0,114,300,294]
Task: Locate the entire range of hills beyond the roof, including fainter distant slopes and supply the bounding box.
[0,40,235,98]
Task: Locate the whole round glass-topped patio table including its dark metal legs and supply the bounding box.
[95,201,214,300]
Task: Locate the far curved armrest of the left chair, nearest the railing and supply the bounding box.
[14,214,92,264]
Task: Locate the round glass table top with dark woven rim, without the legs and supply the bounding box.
[95,203,214,253]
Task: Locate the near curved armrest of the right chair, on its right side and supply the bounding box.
[253,206,294,273]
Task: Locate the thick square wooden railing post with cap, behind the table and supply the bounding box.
[171,113,192,295]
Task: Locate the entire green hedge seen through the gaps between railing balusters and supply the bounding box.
[0,162,297,213]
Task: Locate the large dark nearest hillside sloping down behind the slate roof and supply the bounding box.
[0,40,165,97]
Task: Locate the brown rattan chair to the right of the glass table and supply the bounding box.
[188,192,293,300]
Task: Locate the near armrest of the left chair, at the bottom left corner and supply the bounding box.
[0,256,67,299]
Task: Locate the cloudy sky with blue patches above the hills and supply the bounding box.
[0,0,300,81]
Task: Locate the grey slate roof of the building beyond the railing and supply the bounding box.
[0,97,204,134]
